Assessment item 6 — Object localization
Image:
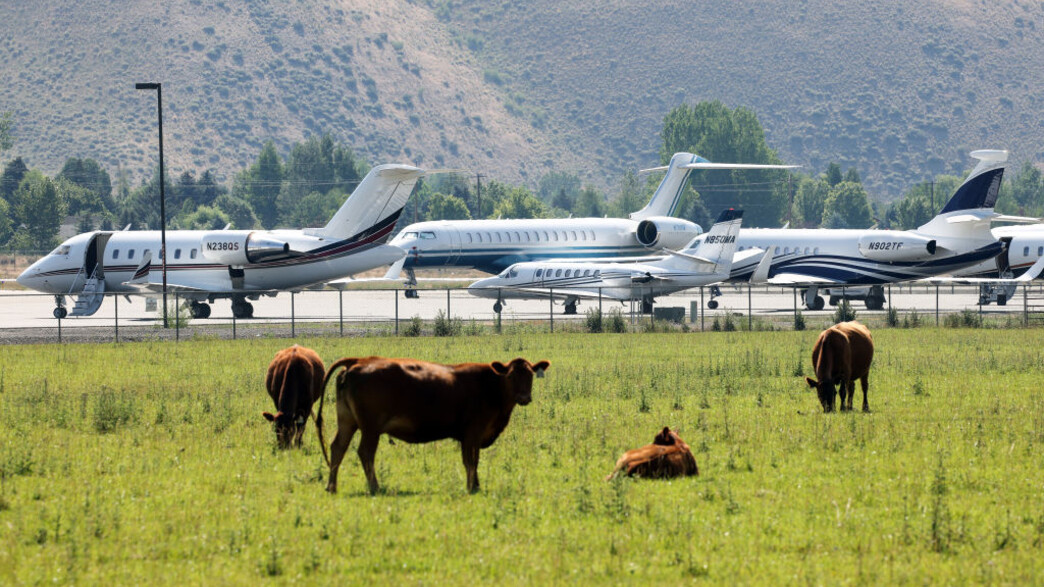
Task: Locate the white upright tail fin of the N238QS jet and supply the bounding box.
[308,164,424,242]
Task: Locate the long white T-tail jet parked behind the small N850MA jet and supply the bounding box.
[387,152,799,298]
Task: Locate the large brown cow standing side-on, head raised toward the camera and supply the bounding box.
[319,357,550,494]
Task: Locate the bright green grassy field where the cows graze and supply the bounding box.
[0,328,1044,585]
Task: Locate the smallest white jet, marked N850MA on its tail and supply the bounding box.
[468,210,764,314]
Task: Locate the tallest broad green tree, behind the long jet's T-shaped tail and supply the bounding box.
[660,100,789,227]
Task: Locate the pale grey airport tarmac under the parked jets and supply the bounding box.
[0,283,1044,343]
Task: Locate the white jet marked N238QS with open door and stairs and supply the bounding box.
[18,165,425,318]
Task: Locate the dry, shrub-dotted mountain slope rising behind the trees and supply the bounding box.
[0,0,1044,199]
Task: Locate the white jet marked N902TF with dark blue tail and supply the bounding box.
[722,150,1007,310]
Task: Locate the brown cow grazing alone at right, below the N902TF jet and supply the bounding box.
[805,322,874,412]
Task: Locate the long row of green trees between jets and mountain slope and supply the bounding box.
[0,101,1044,251]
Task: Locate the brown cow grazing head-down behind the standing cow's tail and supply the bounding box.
[262,345,326,448]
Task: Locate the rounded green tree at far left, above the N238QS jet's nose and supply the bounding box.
[13,169,67,250]
